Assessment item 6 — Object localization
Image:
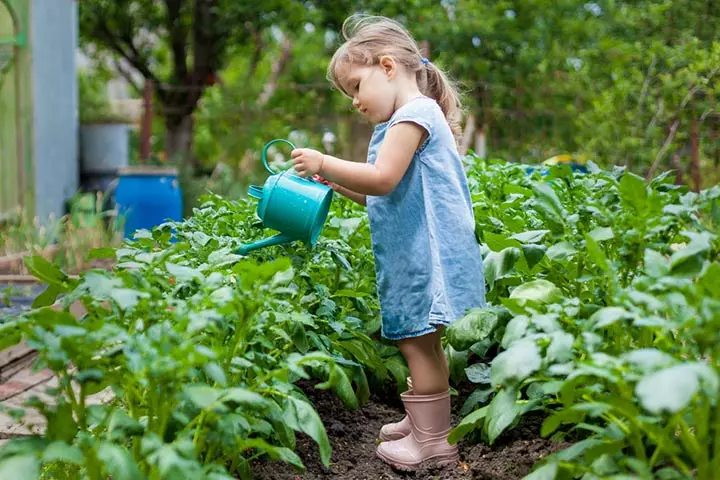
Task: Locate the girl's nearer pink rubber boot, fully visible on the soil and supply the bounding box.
[376,390,460,471]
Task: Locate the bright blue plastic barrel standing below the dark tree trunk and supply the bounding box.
[115,167,183,238]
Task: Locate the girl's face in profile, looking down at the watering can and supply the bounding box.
[341,64,398,124]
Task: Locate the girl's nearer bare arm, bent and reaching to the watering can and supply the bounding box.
[292,122,427,196]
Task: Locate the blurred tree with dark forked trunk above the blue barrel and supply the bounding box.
[80,0,306,171]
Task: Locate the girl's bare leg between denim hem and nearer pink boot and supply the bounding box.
[399,331,450,395]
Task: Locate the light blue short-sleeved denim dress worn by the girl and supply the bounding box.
[367,97,485,340]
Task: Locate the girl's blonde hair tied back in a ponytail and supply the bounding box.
[327,14,461,137]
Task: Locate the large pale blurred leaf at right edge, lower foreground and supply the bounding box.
[635,363,719,414]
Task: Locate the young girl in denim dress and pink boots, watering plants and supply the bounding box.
[292,16,485,470]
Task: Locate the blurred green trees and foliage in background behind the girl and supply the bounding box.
[80,0,720,203]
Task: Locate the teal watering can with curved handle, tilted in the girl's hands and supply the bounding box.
[238,138,333,255]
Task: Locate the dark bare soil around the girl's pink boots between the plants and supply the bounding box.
[253,385,567,480]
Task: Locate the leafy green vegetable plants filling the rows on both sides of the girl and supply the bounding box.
[0,157,720,480]
